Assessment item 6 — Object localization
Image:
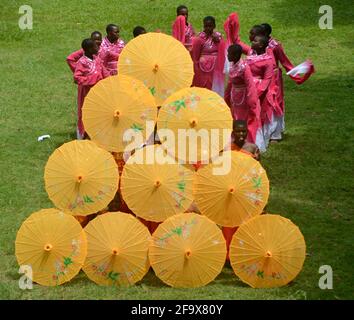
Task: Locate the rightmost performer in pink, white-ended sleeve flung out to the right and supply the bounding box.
[261,23,313,141]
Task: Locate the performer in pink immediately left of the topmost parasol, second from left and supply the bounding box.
[99,24,125,75]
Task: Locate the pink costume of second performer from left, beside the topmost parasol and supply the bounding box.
[98,37,125,75]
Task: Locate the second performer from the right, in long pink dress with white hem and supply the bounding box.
[246,36,279,151]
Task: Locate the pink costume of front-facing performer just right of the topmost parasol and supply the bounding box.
[192,32,225,97]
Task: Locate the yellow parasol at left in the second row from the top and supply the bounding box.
[82,75,156,152]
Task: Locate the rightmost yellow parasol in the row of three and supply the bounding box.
[193,151,269,227]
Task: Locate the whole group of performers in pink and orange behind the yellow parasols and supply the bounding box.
[67,5,314,260]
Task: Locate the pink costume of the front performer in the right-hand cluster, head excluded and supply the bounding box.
[225,59,265,152]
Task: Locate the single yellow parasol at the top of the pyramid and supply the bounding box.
[118,32,194,105]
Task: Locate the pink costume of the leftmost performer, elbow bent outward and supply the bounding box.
[74,55,109,139]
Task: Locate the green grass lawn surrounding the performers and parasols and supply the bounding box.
[0,0,354,299]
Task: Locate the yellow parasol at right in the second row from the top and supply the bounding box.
[157,87,232,163]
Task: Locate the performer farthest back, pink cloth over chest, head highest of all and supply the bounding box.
[172,5,195,52]
